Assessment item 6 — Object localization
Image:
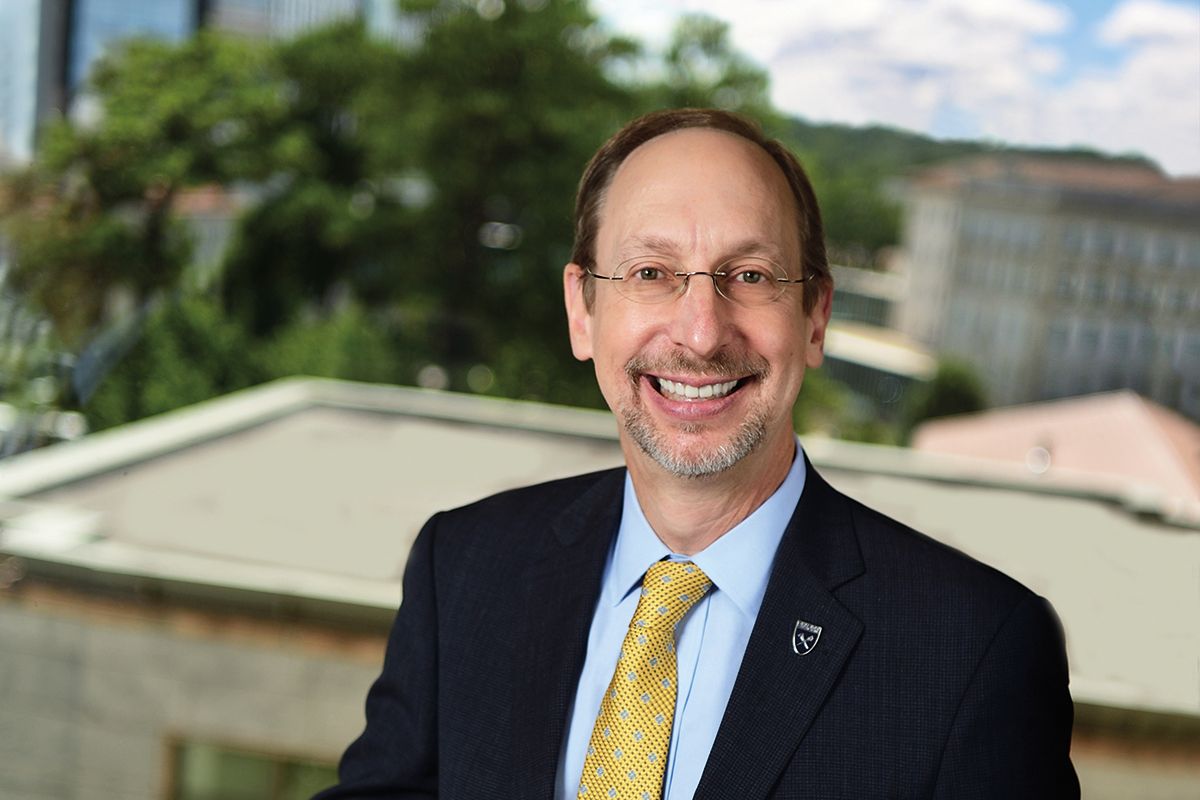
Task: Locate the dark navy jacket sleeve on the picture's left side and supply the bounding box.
[313,516,438,800]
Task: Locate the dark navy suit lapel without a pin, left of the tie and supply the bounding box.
[512,470,625,800]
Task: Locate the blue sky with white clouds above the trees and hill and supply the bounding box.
[592,0,1200,175]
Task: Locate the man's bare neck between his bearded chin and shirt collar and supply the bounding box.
[622,435,797,555]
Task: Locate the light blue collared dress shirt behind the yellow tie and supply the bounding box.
[554,440,804,800]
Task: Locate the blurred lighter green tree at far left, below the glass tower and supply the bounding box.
[0,35,283,348]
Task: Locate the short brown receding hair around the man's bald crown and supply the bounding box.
[571,108,833,313]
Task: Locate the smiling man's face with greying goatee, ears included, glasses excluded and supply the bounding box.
[565,128,829,476]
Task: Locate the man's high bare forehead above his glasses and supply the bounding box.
[598,128,799,261]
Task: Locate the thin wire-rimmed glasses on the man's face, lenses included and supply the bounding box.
[587,255,808,307]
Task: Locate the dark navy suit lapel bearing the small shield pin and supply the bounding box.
[695,464,864,800]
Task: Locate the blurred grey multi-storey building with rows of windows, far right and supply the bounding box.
[898,155,1200,420]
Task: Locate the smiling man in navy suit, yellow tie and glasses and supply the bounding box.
[324,110,1079,800]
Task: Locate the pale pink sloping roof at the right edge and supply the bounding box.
[912,390,1200,501]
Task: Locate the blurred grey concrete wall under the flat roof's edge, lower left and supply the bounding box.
[0,589,383,800]
